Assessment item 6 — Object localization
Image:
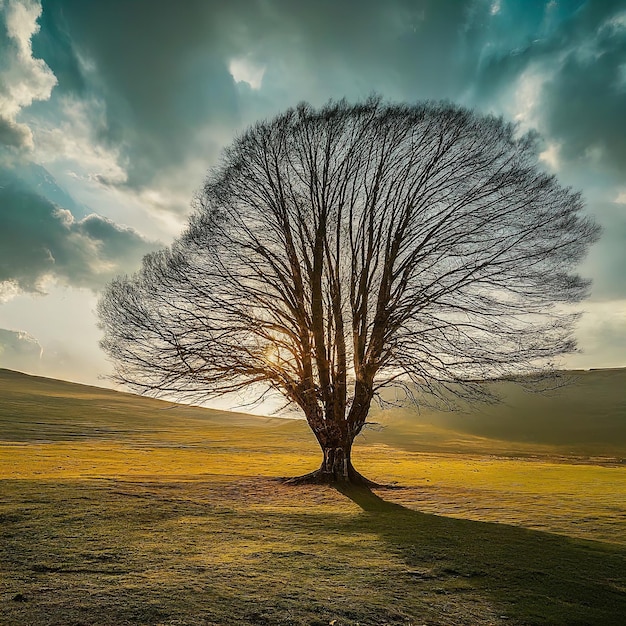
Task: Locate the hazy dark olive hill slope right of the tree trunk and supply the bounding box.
[371,368,626,456]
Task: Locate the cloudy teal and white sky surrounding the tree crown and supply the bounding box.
[0,0,626,384]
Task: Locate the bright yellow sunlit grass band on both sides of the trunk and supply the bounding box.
[0,432,626,544]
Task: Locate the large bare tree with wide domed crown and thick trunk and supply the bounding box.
[98,98,598,482]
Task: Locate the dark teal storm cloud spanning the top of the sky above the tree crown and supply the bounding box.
[26,0,626,187]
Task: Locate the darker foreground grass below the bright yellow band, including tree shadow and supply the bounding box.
[0,477,626,626]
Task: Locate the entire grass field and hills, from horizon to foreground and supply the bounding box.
[0,370,626,626]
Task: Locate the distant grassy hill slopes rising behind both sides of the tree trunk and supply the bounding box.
[0,369,626,458]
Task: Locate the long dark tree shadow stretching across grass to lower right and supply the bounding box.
[338,487,626,626]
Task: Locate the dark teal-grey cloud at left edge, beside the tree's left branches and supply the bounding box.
[0,169,157,292]
